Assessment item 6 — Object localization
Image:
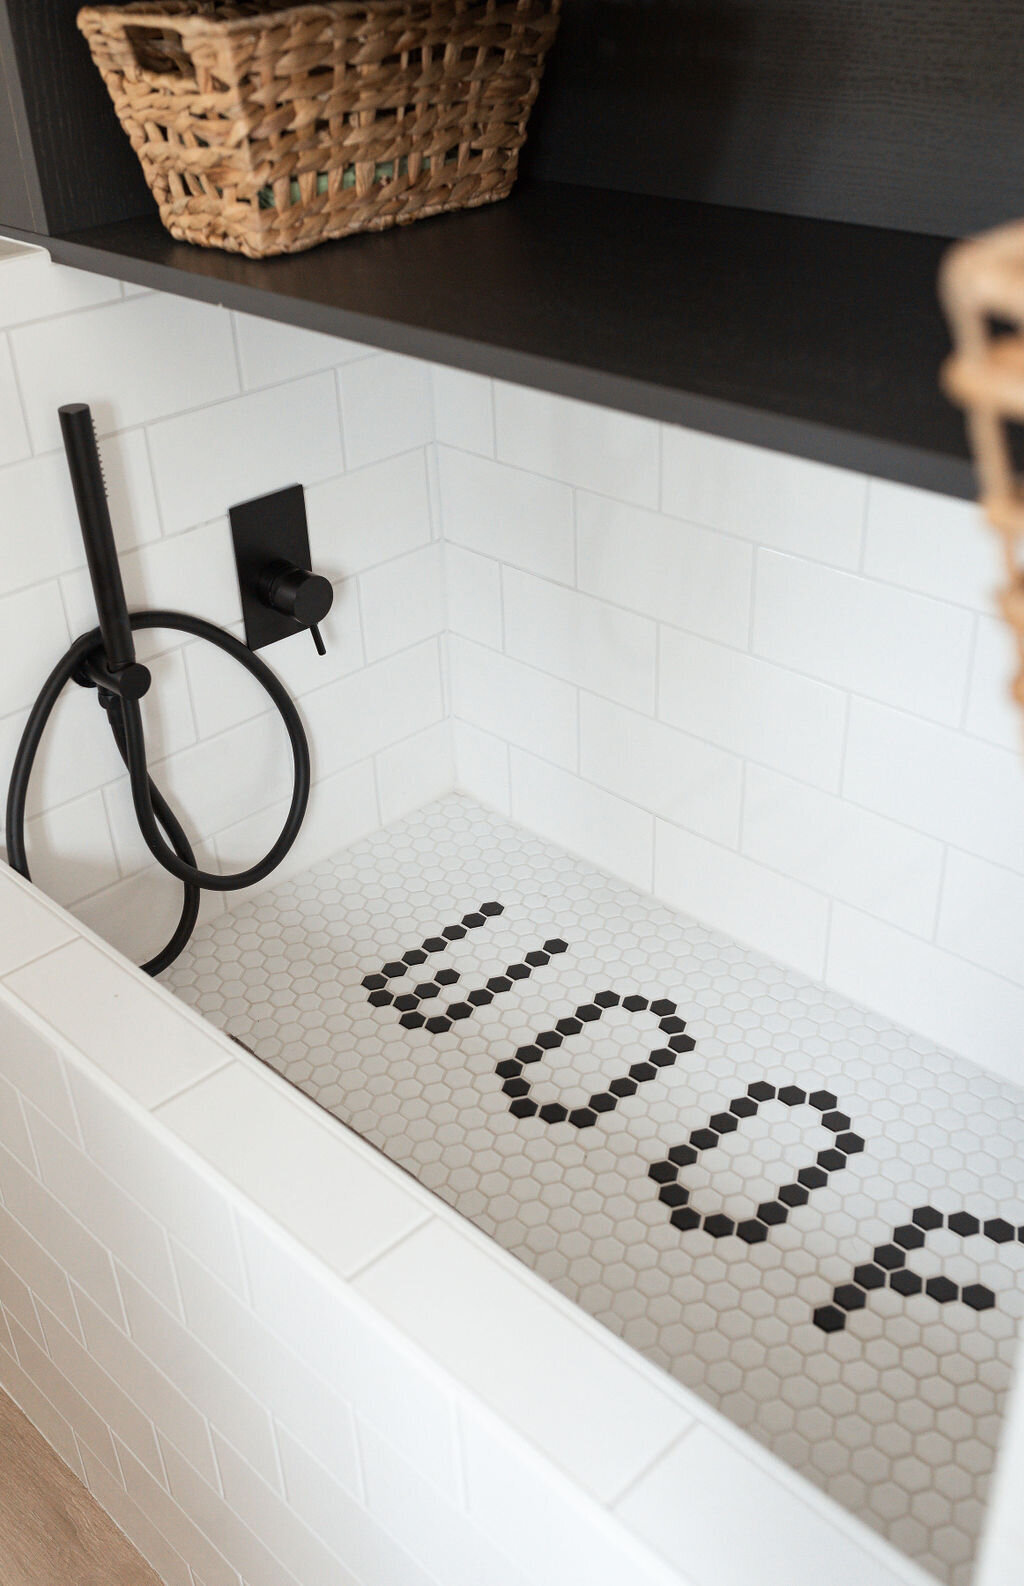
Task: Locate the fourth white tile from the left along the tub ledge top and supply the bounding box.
[355,1220,688,1499]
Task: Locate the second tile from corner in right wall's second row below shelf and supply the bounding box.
[577,492,755,647]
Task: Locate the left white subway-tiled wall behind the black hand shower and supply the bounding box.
[0,249,450,969]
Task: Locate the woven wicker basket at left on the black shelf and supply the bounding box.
[78,0,561,259]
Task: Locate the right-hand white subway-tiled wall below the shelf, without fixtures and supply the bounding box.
[434,371,1024,1082]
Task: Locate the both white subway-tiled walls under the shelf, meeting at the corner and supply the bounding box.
[0,252,1024,1078]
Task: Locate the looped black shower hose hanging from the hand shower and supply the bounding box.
[6,611,309,975]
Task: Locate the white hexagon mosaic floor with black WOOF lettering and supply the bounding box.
[163,795,1024,1586]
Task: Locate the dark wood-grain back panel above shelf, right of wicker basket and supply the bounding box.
[528,0,1024,236]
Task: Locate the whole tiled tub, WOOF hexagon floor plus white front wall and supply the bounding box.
[0,798,1024,1586]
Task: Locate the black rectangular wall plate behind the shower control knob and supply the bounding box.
[230,485,309,650]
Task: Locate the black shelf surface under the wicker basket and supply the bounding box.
[18,182,973,496]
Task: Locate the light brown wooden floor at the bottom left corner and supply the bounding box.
[0,1391,160,1586]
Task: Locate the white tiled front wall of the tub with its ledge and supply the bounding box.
[0,868,930,1586]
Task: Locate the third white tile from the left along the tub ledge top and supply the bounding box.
[159,1063,425,1274]
